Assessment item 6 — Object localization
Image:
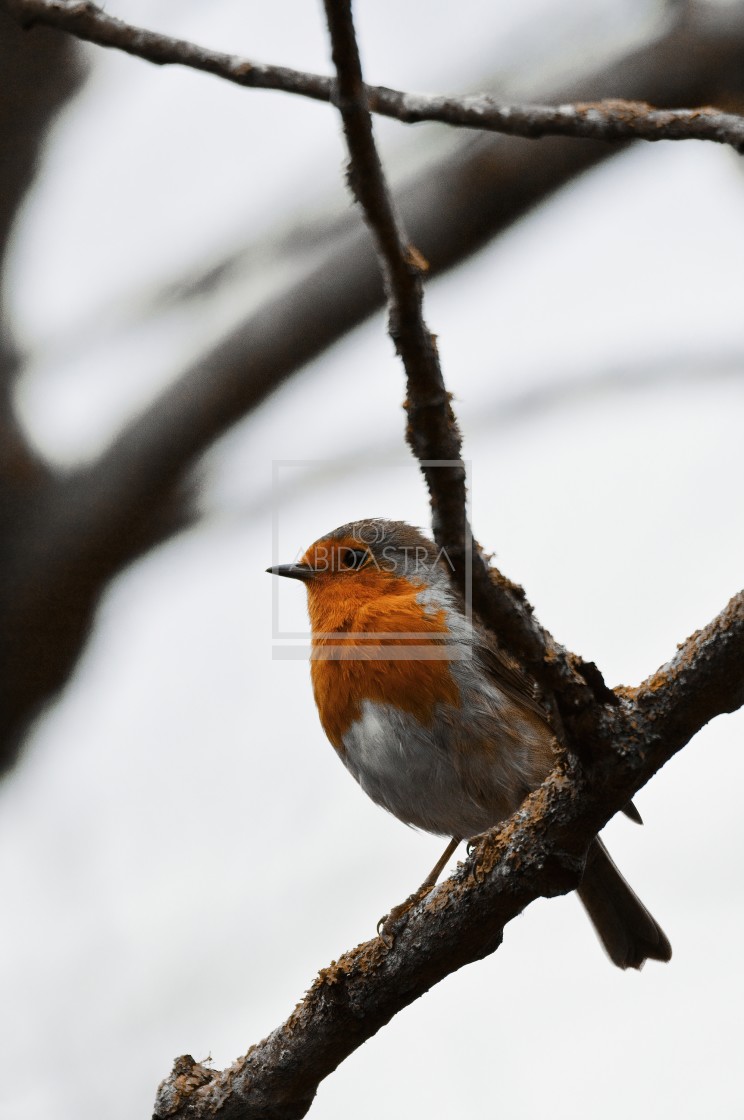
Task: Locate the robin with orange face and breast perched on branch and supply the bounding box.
[268,519,671,969]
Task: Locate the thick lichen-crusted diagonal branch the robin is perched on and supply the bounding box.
[155,592,744,1120]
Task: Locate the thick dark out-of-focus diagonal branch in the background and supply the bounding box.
[0,4,744,767]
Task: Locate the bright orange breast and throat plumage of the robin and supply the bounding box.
[308,568,461,754]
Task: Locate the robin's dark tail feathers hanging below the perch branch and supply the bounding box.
[578,837,671,969]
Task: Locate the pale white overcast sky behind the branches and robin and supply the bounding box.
[0,0,744,1120]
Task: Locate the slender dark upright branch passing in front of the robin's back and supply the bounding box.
[325,0,614,748]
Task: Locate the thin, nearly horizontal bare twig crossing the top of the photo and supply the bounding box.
[6,0,744,151]
